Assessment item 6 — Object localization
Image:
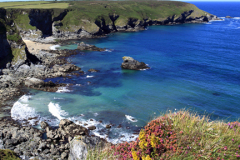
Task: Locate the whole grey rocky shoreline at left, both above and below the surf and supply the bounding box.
[0,38,108,160]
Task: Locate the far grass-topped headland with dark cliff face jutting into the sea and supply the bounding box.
[5,2,217,40]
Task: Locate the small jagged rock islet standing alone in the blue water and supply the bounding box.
[121,56,150,70]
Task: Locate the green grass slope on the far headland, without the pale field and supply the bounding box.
[59,1,205,31]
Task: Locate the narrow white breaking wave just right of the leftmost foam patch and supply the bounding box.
[48,102,68,120]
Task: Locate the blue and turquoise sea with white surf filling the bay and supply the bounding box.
[11,2,240,143]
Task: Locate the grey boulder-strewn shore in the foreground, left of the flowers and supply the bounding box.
[0,117,110,160]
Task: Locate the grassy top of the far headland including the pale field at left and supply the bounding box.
[0,1,206,19]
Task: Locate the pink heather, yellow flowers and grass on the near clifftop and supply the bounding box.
[89,111,240,160]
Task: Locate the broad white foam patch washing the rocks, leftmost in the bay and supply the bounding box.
[11,95,39,120]
